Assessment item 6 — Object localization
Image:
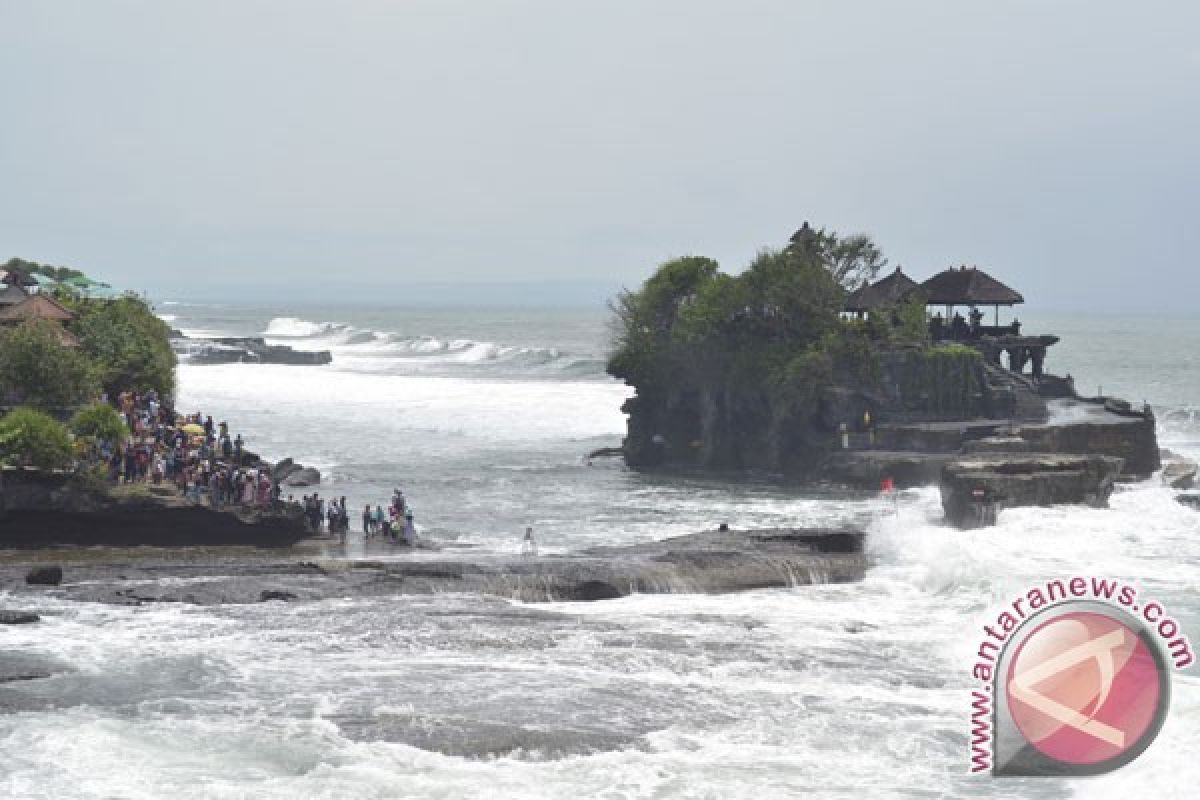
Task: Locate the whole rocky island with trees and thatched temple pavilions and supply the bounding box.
[608,223,1162,523]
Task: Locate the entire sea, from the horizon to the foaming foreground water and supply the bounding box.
[0,301,1200,800]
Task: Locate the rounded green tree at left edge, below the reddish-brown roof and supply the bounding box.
[0,319,96,409]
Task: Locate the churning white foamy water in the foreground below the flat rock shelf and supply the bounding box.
[0,485,1200,799]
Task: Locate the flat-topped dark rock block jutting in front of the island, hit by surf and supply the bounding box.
[941,453,1121,528]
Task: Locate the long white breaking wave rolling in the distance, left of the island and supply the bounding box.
[263,317,604,378]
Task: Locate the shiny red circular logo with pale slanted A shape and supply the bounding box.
[1004,612,1166,764]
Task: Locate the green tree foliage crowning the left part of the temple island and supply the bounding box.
[608,231,902,431]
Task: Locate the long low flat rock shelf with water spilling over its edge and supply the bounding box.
[11,529,866,604]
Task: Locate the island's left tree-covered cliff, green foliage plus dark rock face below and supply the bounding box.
[608,225,896,471]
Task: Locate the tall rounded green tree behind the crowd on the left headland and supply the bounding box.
[72,294,176,397]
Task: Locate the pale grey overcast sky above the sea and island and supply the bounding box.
[0,0,1200,313]
